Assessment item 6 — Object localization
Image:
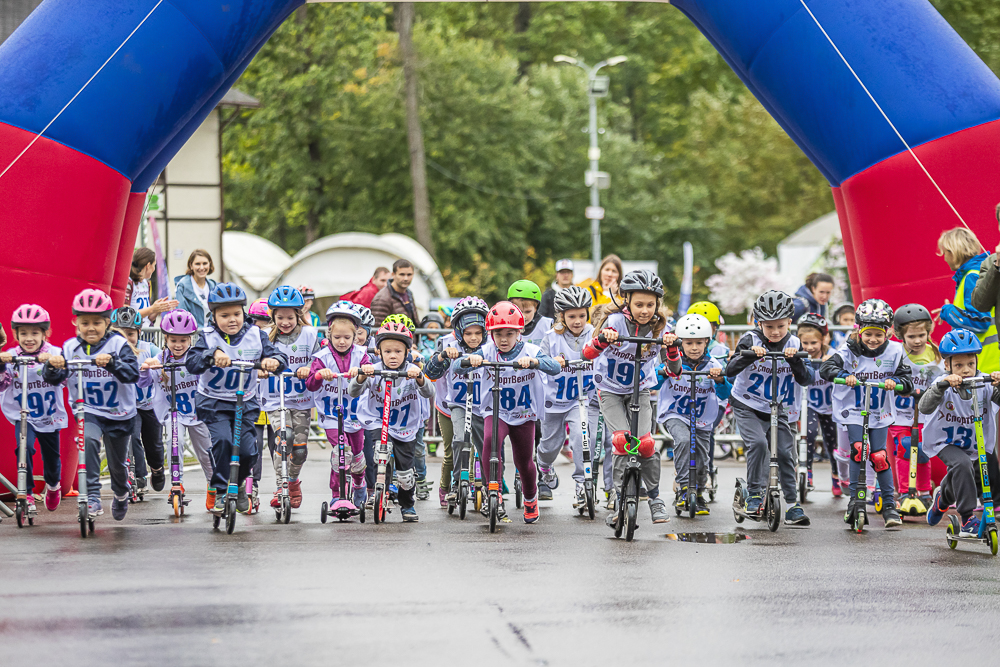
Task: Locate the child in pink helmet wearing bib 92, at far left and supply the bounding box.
[0,303,69,512]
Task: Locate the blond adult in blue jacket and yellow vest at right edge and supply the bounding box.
[931,227,1000,373]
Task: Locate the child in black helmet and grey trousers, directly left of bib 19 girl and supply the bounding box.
[538,285,598,509]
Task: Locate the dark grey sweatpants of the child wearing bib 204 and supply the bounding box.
[728,401,795,503]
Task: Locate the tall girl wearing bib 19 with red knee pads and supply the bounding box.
[583,269,681,529]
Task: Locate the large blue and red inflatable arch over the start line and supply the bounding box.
[0,0,1000,496]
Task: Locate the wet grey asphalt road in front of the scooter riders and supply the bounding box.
[0,449,1000,667]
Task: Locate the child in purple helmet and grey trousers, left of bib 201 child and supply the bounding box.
[139,309,215,512]
